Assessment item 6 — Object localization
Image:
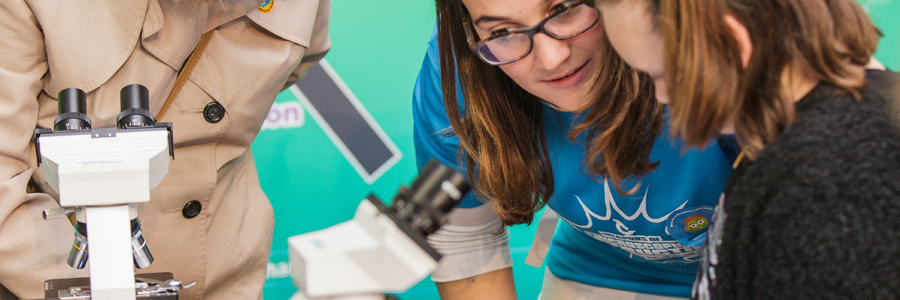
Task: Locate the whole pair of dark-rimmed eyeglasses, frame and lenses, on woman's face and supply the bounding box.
[463,0,600,66]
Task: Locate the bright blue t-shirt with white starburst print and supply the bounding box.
[413,29,737,297]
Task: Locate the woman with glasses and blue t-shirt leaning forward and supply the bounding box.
[413,0,737,300]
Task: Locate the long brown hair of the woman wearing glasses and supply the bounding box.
[435,0,662,225]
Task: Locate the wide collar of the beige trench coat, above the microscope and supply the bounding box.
[41,0,261,98]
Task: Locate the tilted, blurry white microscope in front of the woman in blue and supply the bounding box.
[288,160,469,300]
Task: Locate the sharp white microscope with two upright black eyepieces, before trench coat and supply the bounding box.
[34,84,193,300]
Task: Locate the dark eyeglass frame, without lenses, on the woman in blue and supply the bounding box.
[459,0,600,66]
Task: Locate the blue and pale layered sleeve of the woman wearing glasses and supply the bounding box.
[413,25,512,282]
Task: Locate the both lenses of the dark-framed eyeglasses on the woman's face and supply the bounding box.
[475,4,599,63]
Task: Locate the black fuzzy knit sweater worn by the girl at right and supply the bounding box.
[693,71,900,299]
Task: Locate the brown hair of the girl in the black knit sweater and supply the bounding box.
[646,0,881,159]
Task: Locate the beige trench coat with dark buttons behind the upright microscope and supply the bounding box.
[0,0,330,299]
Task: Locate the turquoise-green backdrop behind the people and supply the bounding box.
[252,0,900,300]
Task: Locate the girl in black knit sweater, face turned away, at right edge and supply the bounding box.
[599,0,900,299]
